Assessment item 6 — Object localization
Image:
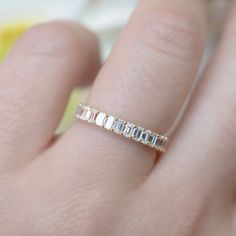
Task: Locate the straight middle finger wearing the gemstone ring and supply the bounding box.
[59,0,205,184]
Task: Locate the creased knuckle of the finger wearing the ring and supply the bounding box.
[133,9,202,60]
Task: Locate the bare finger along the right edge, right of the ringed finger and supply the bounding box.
[149,6,236,194]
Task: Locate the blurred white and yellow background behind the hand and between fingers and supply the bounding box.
[0,0,233,132]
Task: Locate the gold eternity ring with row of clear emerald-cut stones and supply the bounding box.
[75,104,169,152]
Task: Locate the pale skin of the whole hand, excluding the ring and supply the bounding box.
[0,0,236,236]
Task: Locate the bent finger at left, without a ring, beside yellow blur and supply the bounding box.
[0,19,99,168]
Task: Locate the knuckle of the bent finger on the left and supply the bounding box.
[17,22,97,57]
